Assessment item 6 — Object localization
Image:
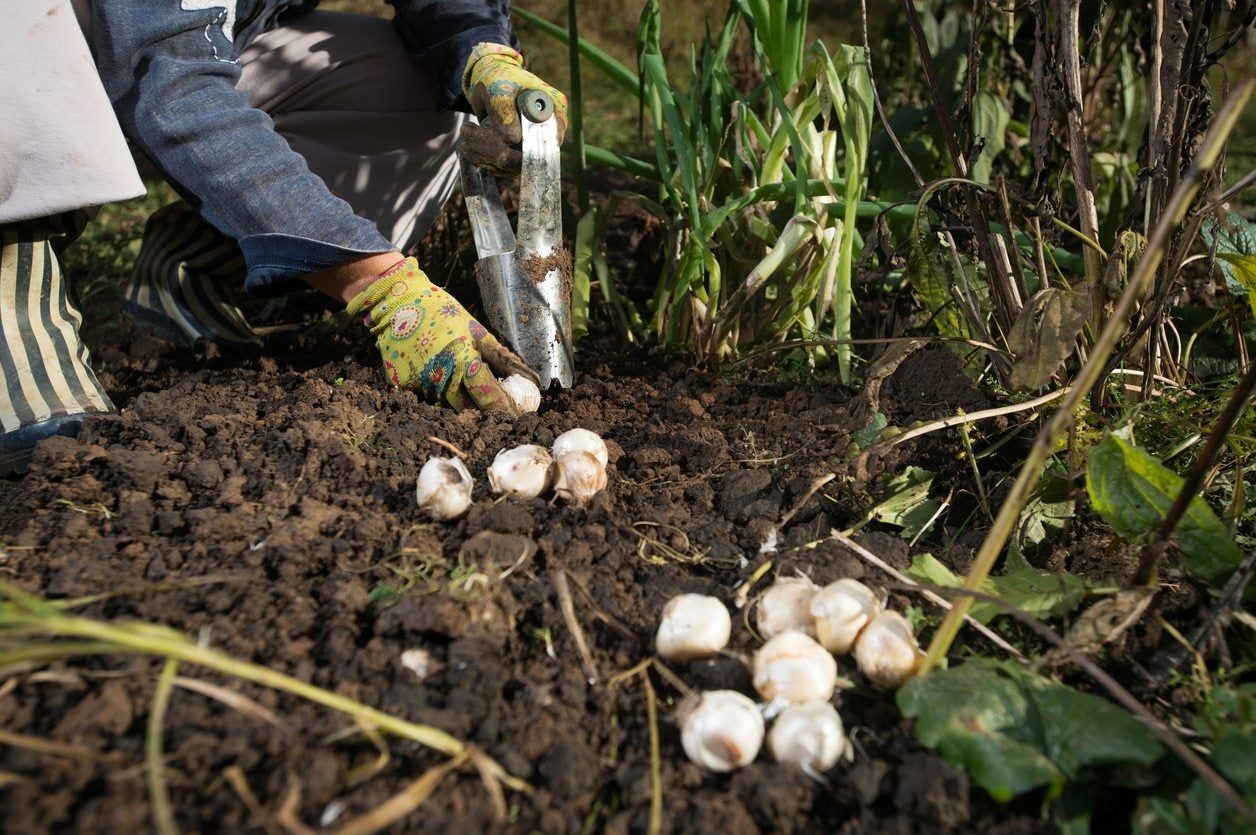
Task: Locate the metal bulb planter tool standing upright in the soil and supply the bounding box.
[458,90,574,391]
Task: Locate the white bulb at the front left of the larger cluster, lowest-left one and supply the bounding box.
[678,691,764,771]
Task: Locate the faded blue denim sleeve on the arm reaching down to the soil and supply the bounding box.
[90,0,396,295]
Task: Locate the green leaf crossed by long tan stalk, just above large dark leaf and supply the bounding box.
[906,554,1090,623]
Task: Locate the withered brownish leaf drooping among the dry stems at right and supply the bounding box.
[1007,288,1091,392]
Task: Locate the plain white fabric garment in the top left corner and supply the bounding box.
[0,0,144,224]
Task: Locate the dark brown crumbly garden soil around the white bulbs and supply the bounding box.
[0,307,1070,835]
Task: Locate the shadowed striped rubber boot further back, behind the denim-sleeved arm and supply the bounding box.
[123,203,261,347]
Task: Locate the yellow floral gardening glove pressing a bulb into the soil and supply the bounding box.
[348,257,536,414]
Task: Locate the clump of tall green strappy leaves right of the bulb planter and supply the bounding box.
[516,0,889,380]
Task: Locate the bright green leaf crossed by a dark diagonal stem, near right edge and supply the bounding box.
[1086,433,1243,585]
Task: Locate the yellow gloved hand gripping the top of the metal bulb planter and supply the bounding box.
[462,43,566,176]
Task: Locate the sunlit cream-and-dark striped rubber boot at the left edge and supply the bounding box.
[0,216,114,476]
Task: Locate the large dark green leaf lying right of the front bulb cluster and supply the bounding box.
[898,658,1163,800]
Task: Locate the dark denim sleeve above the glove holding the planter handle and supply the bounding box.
[388,0,519,112]
